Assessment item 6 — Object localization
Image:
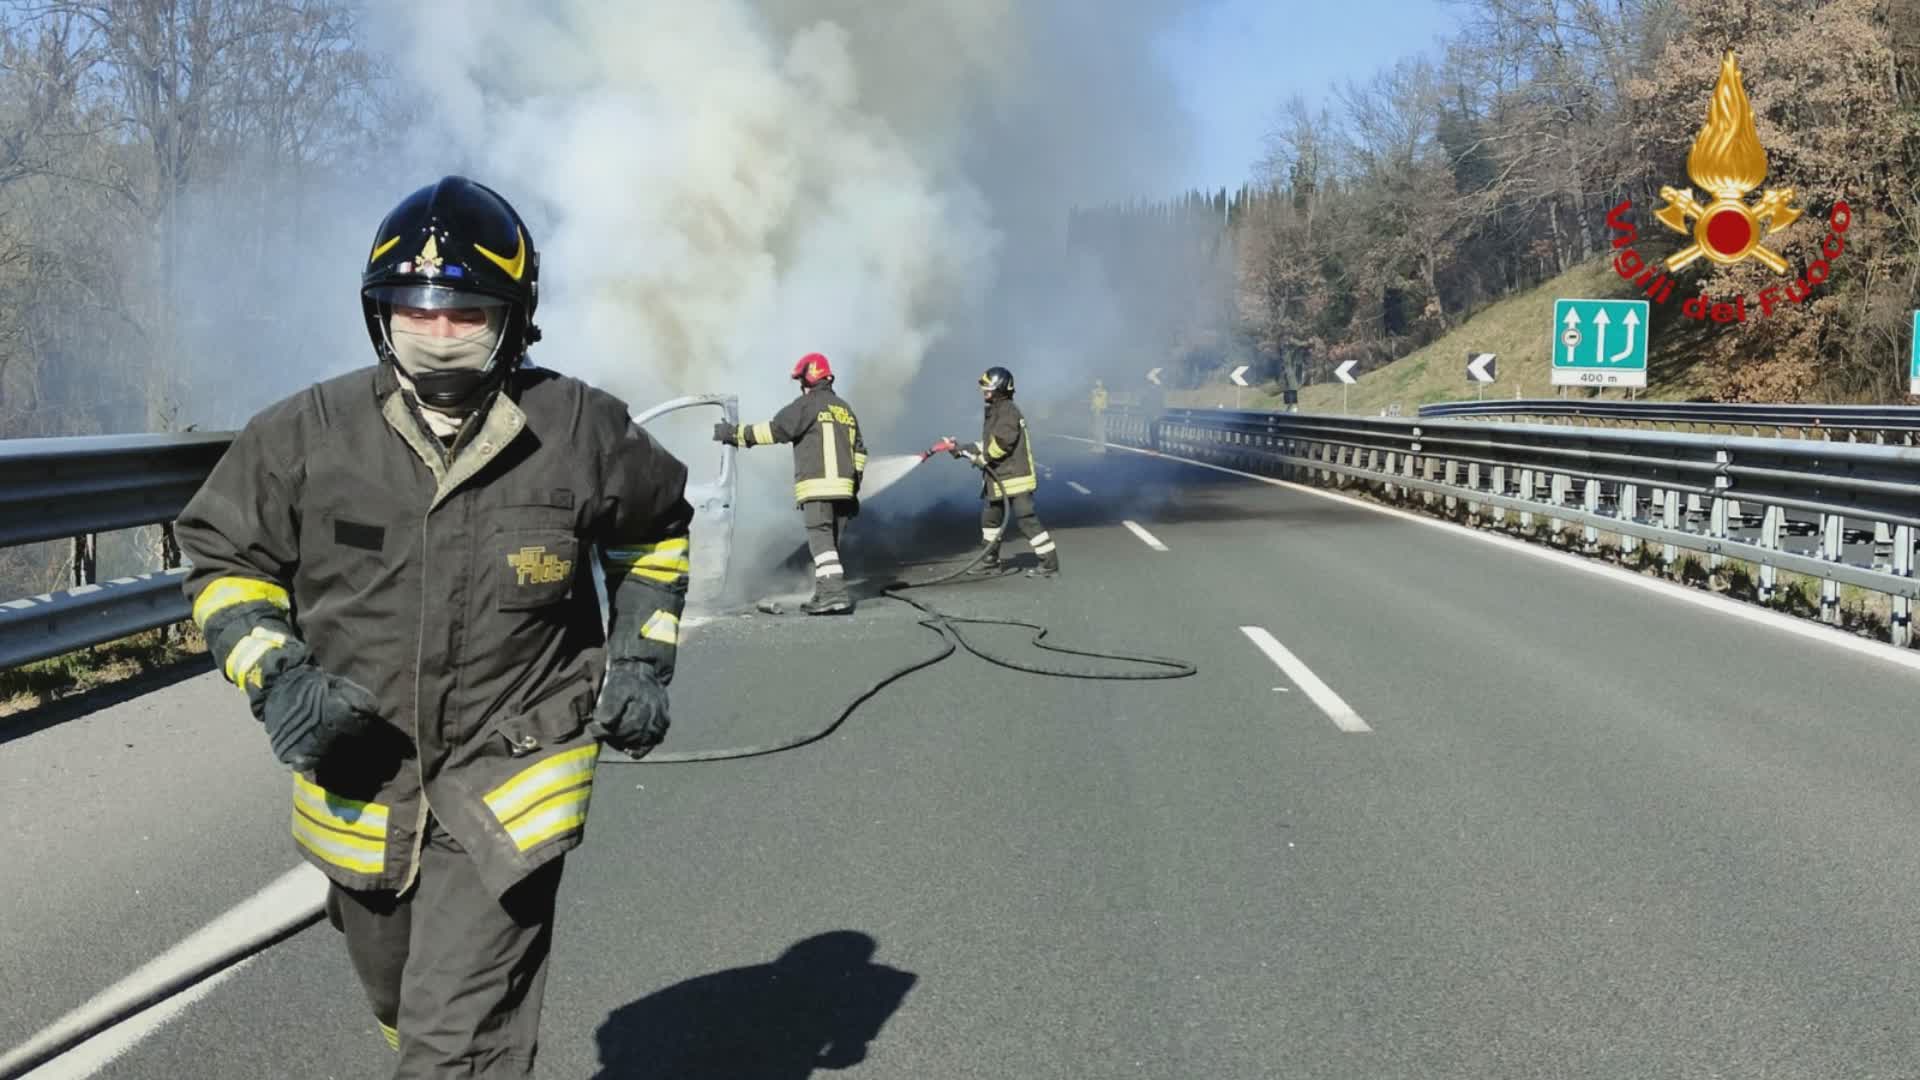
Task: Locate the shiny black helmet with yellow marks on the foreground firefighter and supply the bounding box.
[361,177,540,407]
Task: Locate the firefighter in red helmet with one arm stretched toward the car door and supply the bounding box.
[714,352,866,615]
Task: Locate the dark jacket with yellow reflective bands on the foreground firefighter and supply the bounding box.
[179,365,693,896]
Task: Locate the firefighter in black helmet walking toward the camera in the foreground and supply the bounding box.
[177,177,693,1080]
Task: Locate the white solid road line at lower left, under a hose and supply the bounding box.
[0,863,326,1080]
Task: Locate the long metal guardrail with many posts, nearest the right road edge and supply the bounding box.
[1108,401,1920,646]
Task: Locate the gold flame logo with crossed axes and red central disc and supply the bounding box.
[1653,50,1801,273]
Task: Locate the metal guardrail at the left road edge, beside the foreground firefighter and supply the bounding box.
[0,432,232,669]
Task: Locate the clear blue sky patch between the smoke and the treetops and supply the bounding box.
[1162,0,1461,188]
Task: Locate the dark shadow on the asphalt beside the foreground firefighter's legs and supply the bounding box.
[593,930,920,1080]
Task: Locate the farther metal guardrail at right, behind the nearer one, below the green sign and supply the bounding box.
[1419,398,1920,432]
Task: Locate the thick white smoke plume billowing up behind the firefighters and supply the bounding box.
[361,0,1190,591]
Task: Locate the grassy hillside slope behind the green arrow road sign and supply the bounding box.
[1167,259,1699,415]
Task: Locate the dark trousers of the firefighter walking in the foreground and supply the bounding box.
[326,817,566,1080]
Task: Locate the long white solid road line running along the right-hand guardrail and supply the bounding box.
[1054,434,1920,673]
